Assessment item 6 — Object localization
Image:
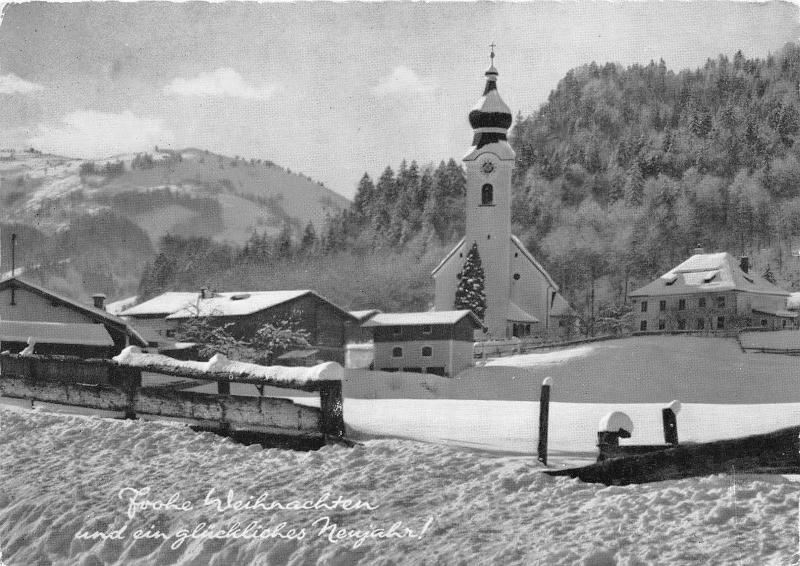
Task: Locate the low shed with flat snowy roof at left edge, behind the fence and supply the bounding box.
[0,320,114,358]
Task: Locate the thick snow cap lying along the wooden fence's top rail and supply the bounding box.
[113,346,344,384]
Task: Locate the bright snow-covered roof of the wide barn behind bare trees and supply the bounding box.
[120,290,312,320]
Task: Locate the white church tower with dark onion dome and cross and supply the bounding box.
[463,49,515,336]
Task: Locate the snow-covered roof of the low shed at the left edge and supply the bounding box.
[0,320,114,347]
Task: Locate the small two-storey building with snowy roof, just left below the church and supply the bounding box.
[362,310,483,377]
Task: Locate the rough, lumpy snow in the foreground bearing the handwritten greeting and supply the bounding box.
[0,407,798,566]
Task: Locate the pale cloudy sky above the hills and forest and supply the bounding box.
[0,1,800,197]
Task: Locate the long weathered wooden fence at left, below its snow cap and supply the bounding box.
[0,354,345,447]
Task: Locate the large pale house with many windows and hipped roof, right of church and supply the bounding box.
[629,253,798,331]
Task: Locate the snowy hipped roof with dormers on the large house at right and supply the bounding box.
[628,252,789,297]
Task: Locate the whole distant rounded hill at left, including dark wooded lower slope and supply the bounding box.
[0,149,348,299]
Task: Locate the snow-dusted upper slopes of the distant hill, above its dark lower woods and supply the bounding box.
[0,149,347,244]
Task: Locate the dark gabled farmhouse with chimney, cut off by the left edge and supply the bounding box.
[0,277,148,355]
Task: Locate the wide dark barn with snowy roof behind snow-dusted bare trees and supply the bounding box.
[120,289,358,363]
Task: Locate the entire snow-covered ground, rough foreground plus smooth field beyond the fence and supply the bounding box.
[0,337,800,566]
